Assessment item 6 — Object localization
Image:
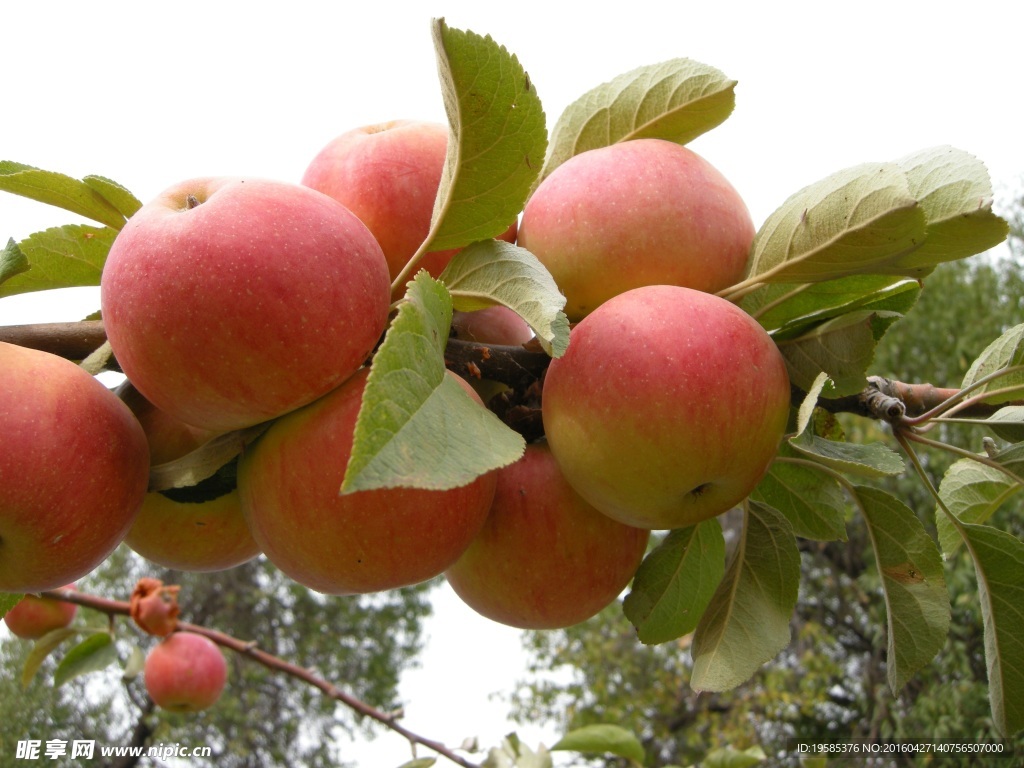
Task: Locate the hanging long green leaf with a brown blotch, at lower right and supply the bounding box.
[855,486,949,694]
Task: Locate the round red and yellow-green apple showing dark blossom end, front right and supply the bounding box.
[542,286,790,528]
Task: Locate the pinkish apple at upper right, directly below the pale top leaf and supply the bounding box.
[519,139,754,321]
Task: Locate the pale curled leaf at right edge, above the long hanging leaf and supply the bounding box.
[935,445,1024,555]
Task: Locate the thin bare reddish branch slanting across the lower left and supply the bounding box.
[41,590,479,768]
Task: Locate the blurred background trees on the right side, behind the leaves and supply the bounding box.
[512,188,1024,766]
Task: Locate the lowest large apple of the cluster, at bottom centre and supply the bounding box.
[444,441,650,629]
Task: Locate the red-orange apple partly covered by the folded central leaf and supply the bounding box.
[239,370,496,594]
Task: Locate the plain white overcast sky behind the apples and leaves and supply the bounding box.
[0,0,1024,767]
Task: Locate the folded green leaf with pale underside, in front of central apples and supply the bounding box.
[341,271,525,493]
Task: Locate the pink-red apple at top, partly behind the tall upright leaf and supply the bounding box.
[302,120,516,298]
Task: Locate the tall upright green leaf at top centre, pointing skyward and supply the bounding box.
[421,19,548,251]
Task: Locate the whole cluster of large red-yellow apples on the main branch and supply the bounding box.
[0,121,790,651]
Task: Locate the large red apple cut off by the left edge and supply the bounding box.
[0,343,150,592]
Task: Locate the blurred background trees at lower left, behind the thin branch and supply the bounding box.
[0,547,431,768]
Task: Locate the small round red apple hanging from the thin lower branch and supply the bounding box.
[142,632,227,712]
